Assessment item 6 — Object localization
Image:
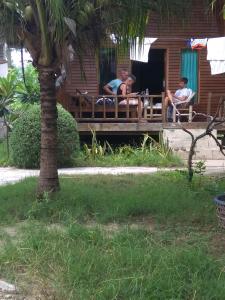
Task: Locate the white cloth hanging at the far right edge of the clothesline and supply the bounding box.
[207,37,225,75]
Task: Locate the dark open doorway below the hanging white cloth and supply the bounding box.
[132,49,166,94]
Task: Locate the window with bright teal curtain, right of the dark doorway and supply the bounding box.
[181,49,199,99]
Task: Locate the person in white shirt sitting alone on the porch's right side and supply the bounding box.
[165,77,191,122]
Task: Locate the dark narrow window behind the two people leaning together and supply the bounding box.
[99,48,116,94]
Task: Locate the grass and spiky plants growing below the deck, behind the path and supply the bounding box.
[75,131,183,167]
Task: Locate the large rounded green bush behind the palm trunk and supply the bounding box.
[10,105,79,168]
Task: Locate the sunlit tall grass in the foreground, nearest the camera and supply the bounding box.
[0,224,225,300]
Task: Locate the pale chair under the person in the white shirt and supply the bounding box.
[172,89,196,123]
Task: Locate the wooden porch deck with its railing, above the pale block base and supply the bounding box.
[58,92,225,135]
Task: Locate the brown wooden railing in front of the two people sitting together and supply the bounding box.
[67,93,166,123]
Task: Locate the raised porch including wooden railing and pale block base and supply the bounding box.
[62,93,225,160]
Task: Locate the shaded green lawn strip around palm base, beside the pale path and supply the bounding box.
[0,172,220,225]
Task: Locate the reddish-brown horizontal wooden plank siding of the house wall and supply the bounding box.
[60,0,225,119]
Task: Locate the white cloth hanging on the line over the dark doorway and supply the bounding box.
[130,38,157,63]
